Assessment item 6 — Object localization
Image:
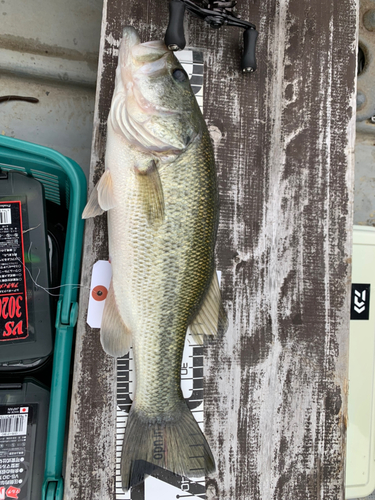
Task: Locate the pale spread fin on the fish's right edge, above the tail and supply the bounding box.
[190,270,227,344]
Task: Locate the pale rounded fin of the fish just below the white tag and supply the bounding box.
[100,281,131,358]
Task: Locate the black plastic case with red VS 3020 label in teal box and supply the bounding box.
[0,172,53,372]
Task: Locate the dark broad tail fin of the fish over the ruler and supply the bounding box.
[121,400,215,491]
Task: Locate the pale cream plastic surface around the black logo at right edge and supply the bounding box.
[346,226,375,499]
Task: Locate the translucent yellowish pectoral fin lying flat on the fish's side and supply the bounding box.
[134,160,164,224]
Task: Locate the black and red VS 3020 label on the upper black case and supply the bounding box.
[0,201,29,341]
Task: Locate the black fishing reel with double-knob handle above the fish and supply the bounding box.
[164,0,258,73]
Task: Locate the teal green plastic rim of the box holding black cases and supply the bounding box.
[0,135,87,500]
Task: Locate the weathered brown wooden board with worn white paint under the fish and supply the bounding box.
[65,0,357,500]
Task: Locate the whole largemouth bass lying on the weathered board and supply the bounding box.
[83,27,225,491]
